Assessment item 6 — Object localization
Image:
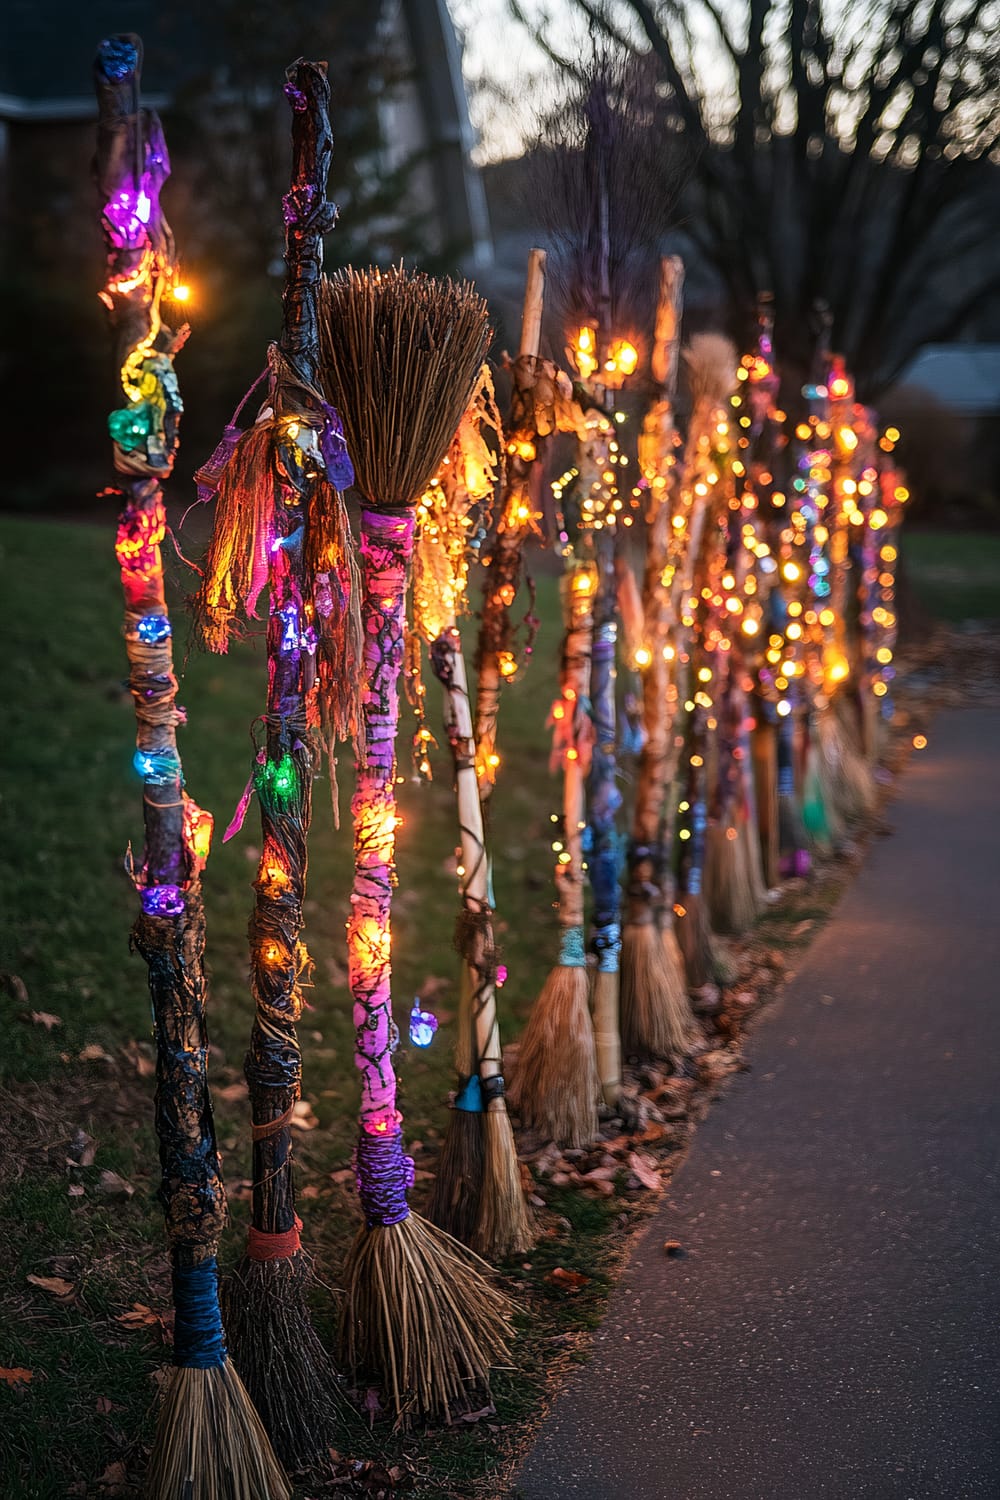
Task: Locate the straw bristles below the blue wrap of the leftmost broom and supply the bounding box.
[145,1359,292,1500]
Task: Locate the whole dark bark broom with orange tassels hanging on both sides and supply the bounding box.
[198,60,360,1467]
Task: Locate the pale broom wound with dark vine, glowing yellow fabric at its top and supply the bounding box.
[412,402,534,1260]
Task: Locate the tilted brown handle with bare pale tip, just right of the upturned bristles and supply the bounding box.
[475,249,546,801]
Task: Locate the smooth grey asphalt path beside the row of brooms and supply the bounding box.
[513,705,1000,1500]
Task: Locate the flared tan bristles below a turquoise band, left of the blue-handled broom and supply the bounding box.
[511,965,601,1146]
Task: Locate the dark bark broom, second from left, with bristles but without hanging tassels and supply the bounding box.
[218,59,339,1467]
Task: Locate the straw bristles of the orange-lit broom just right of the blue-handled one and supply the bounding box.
[621,923,694,1058]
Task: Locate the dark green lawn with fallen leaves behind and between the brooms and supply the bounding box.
[0,518,983,1500]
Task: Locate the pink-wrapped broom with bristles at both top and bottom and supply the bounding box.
[324,267,510,1424]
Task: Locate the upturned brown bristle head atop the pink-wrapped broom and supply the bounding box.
[319,266,492,507]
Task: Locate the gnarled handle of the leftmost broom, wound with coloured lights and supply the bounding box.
[94,35,226,1278]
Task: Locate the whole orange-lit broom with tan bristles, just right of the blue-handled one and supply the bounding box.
[621,255,693,1058]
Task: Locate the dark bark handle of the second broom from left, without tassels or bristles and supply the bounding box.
[244,59,336,1236]
